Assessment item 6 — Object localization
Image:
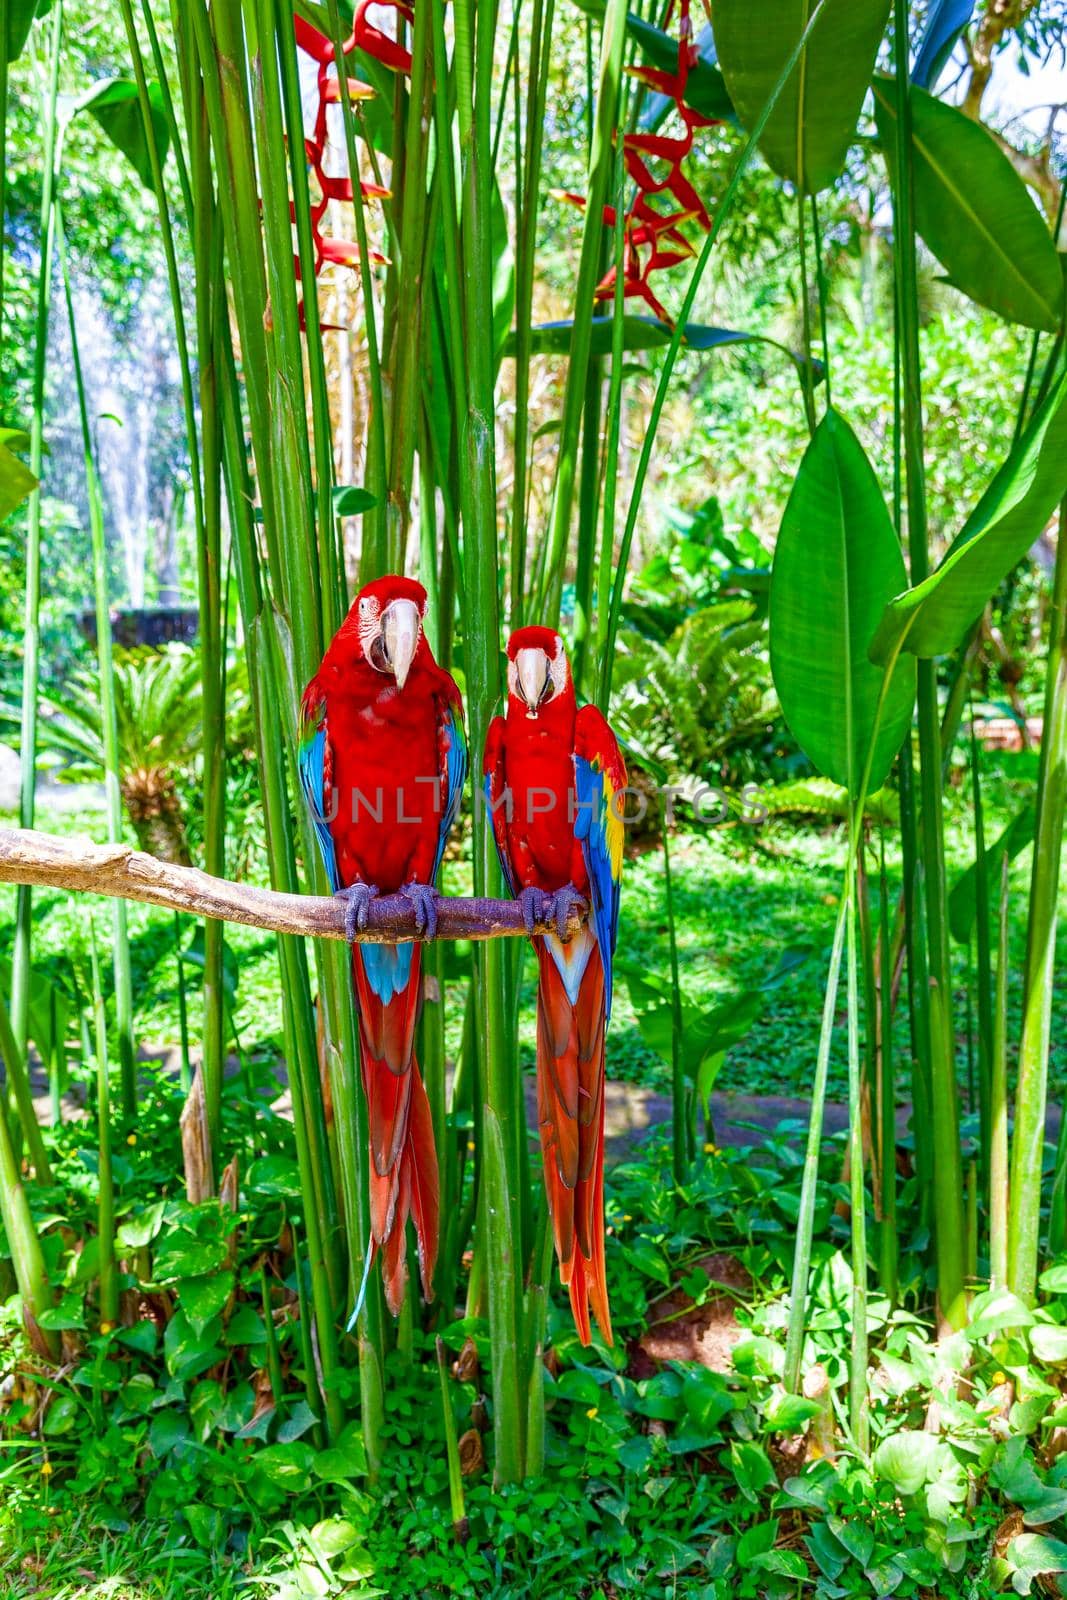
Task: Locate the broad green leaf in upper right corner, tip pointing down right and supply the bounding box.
[873,75,1064,331]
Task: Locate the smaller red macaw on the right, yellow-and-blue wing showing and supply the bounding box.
[485,627,625,1344]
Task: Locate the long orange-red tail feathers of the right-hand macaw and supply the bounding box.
[537,941,613,1344]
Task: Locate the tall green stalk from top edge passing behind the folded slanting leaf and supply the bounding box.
[893,0,966,1328]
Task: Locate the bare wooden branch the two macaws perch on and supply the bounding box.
[0,827,582,944]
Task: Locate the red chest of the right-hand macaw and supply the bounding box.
[504,718,589,894]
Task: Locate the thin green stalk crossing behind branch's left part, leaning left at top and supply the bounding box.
[54,197,138,1118]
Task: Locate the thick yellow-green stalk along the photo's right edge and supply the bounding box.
[1008,502,1067,1301]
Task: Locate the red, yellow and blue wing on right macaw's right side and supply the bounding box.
[574,706,625,1016]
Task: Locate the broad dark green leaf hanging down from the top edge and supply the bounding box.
[715,0,889,194]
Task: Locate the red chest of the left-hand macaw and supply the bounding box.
[325,674,445,894]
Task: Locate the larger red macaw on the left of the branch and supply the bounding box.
[299,578,467,1315]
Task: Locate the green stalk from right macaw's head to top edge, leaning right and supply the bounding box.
[539,0,627,622]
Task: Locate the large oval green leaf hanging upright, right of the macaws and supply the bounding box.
[769,411,915,797]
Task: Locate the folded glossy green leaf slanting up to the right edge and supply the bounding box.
[870,373,1067,661]
